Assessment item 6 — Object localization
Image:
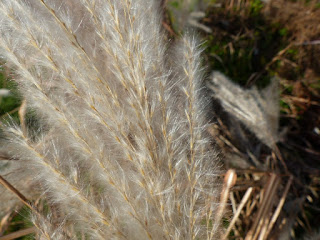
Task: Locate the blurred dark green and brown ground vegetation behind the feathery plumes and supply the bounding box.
[0,0,320,239]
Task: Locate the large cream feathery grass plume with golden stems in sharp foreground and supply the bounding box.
[0,0,219,239]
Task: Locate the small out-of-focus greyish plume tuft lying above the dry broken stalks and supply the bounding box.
[208,72,279,149]
